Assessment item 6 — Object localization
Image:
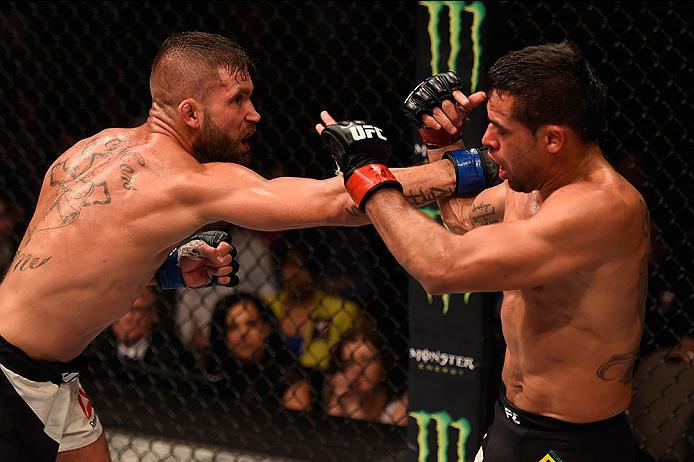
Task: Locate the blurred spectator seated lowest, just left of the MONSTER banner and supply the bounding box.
[323,323,407,425]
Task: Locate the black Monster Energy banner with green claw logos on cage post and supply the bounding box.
[408,1,494,462]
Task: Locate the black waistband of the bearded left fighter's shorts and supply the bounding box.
[0,335,80,383]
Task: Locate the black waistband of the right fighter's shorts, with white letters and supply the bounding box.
[499,386,626,432]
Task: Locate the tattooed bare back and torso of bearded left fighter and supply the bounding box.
[0,129,216,361]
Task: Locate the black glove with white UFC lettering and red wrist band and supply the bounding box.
[321,120,402,212]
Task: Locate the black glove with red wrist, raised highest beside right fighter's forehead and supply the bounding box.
[402,71,463,149]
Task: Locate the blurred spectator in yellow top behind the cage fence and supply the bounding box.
[268,244,360,409]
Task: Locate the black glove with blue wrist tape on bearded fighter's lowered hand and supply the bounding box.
[154,231,239,289]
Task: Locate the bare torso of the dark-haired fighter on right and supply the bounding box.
[501,168,649,423]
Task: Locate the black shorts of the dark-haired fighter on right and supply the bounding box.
[475,391,635,462]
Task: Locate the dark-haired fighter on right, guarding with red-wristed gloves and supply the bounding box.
[317,43,650,462]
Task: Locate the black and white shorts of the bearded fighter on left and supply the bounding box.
[0,336,103,462]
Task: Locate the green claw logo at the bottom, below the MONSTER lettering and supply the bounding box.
[409,411,471,462]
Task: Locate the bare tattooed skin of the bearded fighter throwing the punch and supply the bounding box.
[0,69,453,361]
